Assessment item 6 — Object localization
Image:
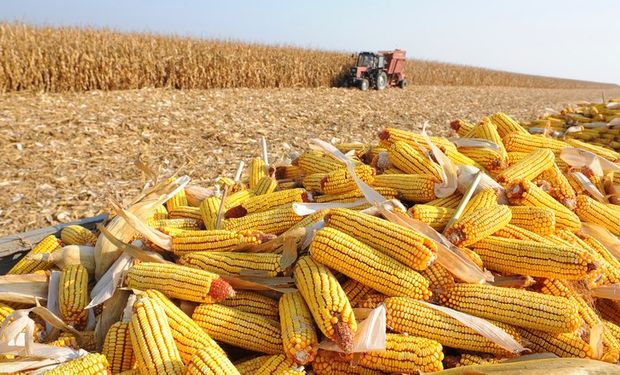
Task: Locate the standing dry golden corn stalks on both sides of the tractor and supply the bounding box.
[0,23,615,92]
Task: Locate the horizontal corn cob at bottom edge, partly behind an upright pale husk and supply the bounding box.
[359,333,443,373]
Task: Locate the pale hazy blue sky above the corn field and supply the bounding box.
[0,0,620,83]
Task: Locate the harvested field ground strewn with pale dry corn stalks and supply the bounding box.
[0,86,620,236]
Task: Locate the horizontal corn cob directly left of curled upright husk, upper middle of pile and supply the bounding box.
[372,174,439,203]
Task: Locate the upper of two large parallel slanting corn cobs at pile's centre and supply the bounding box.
[325,208,437,270]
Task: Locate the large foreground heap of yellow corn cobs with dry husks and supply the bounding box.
[0,107,620,374]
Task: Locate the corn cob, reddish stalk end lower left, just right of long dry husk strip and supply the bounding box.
[446,205,512,246]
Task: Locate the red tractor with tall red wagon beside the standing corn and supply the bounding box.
[343,49,407,91]
